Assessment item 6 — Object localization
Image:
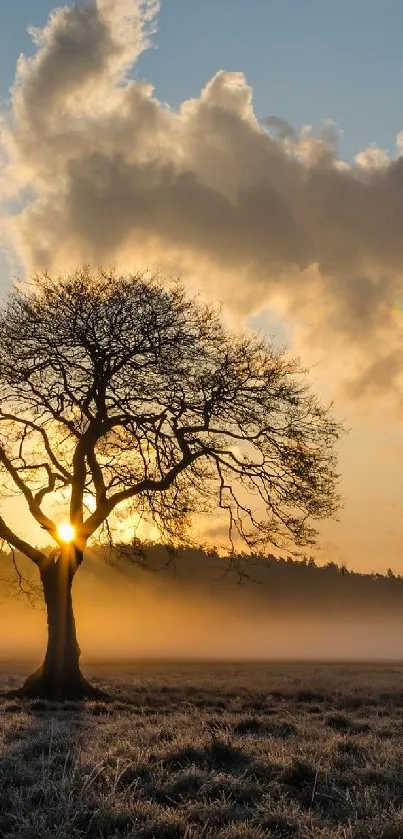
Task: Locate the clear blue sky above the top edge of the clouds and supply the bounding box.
[0,0,403,159]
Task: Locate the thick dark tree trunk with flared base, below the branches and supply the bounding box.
[18,545,101,700]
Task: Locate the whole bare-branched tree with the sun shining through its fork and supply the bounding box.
[0,268,341,699]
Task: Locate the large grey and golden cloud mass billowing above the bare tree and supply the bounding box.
[0,0,403,395]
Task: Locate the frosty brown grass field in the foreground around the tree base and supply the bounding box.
[0,664,403,839]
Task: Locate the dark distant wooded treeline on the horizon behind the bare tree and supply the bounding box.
[0,543,403,614]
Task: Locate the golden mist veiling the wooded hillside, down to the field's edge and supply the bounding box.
[0,551,403,664]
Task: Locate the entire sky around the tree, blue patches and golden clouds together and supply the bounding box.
[0,0,403,573]
